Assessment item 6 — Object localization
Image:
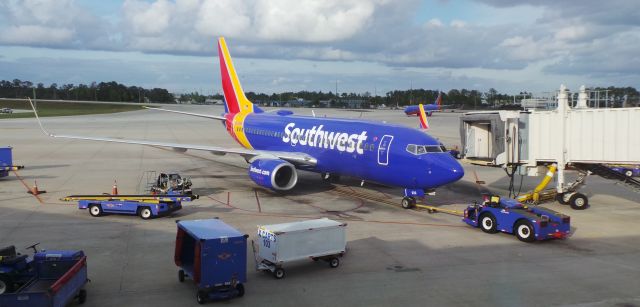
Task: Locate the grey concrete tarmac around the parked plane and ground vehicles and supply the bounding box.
[0,105,640,306]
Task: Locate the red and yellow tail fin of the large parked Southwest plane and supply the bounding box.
[218,37,254,114]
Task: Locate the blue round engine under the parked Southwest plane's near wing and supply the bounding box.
[249,159,298,191]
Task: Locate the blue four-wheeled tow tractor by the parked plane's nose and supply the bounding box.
[462,196,571,242]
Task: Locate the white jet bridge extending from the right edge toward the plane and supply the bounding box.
[460,85,640,208]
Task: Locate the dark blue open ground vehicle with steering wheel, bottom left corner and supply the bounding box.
[0,245,89,307]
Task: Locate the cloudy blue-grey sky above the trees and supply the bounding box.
[0,0,640,95]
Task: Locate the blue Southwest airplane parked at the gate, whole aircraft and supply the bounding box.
[32,37,464,208]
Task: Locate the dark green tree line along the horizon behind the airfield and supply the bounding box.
[0,79,640,108]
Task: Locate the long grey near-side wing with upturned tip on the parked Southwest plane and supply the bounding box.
[29,99,318,166]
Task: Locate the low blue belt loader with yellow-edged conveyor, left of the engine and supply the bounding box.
[61,195,193,220]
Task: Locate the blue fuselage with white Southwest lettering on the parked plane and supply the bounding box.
[233,113,464,189]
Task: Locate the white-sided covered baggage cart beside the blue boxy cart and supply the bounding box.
[252,218,347,279]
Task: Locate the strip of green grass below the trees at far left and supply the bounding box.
[0,100,142,119]
